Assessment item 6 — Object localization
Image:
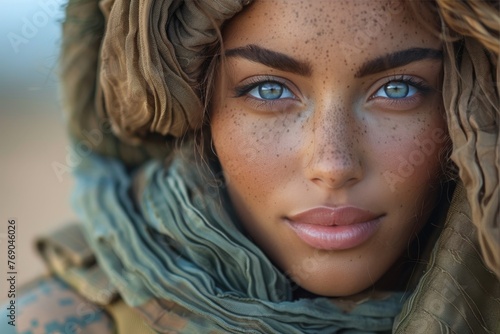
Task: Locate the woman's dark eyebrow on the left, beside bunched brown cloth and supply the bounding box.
[225,44,312,77]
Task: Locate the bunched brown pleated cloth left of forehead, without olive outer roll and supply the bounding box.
[99,0,249,142]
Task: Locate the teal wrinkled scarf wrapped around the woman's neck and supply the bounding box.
[73,149,404,333]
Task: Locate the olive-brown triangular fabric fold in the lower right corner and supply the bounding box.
[393,184,500,334]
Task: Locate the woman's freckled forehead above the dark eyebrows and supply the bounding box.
[223,0,440,62]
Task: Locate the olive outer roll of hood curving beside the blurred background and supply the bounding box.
[59,0,170,166]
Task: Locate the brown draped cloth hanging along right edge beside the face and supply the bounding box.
[437,0,500,278]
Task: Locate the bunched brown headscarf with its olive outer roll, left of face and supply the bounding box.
[61,0,250,165]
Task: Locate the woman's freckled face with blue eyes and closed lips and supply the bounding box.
[211,0,446,296]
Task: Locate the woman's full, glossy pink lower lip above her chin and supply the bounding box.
[287,218,381,250]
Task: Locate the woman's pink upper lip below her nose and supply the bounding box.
[287,206,383,226]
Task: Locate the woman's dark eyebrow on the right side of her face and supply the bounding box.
[354,48,443,78]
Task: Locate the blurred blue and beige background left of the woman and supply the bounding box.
[0,0,74,292]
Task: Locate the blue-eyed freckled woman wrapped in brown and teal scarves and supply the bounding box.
[8,0,500,333]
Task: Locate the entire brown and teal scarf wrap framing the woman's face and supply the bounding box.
[61,0,500,333]
